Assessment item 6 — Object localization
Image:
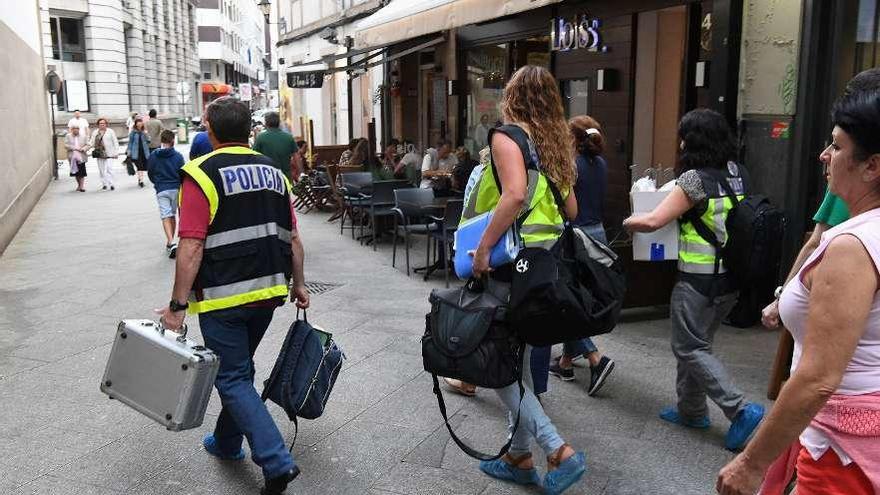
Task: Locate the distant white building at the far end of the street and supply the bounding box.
[197,0,268,108]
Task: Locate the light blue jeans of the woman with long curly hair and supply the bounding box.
[495,345,565,457]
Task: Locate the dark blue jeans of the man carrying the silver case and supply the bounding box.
[199,307,295,479]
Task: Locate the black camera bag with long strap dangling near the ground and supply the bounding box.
[422,279,525,460]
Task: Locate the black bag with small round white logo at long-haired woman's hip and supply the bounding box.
[508,181,626,347]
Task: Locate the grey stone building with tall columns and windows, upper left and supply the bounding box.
[39,0,199,122]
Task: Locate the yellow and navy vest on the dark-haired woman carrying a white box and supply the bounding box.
[678,162,748,275]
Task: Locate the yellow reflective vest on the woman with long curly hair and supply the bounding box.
[461,125,566,249]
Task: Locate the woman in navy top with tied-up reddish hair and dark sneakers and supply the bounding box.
[550,115,614,397]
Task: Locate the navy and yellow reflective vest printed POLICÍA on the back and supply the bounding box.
[182,146,293,313]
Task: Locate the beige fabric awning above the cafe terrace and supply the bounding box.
[354,0,561,48]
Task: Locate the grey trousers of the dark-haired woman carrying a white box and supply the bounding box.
[669,282,745,421]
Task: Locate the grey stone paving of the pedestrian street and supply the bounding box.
[0,153,777,495]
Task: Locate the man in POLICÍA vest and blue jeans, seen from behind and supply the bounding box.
[159,97,309,495]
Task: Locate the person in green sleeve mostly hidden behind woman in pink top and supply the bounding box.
[761,68,880,329]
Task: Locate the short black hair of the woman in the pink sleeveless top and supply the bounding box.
[831,91,880,161]
